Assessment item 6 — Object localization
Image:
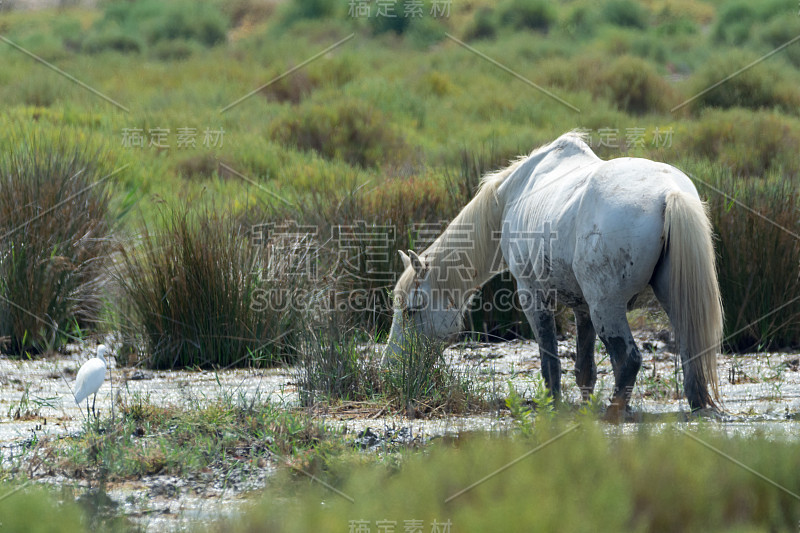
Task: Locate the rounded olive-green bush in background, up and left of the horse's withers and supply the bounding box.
[270,100,409,168]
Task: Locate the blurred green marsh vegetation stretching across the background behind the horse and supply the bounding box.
[0,0,800,349]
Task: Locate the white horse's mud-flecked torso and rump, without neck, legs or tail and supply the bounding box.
[501,142,697,307]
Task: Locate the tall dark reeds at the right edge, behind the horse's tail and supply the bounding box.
[698,166,800,351]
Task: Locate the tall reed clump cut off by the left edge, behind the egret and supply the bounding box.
[0,133,113,355]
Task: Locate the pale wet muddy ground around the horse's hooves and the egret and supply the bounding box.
[0,332,800,531]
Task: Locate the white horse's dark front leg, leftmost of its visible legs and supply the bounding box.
[520,288,561,400]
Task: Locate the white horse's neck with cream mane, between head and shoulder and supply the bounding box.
[425,184,504,307]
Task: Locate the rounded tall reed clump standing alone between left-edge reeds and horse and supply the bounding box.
[116,207,295,368]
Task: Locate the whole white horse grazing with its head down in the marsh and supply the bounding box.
[382,133,722,415]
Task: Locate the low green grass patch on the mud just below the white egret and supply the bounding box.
[32,386,348,483]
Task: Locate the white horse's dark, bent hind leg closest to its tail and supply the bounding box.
[590,303,642,417]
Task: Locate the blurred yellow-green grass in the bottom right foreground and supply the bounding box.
[222,418,800,532]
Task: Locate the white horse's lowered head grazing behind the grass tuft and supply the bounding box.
[381,250,462,364]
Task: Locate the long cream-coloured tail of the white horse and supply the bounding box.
[664,191,722,409]
